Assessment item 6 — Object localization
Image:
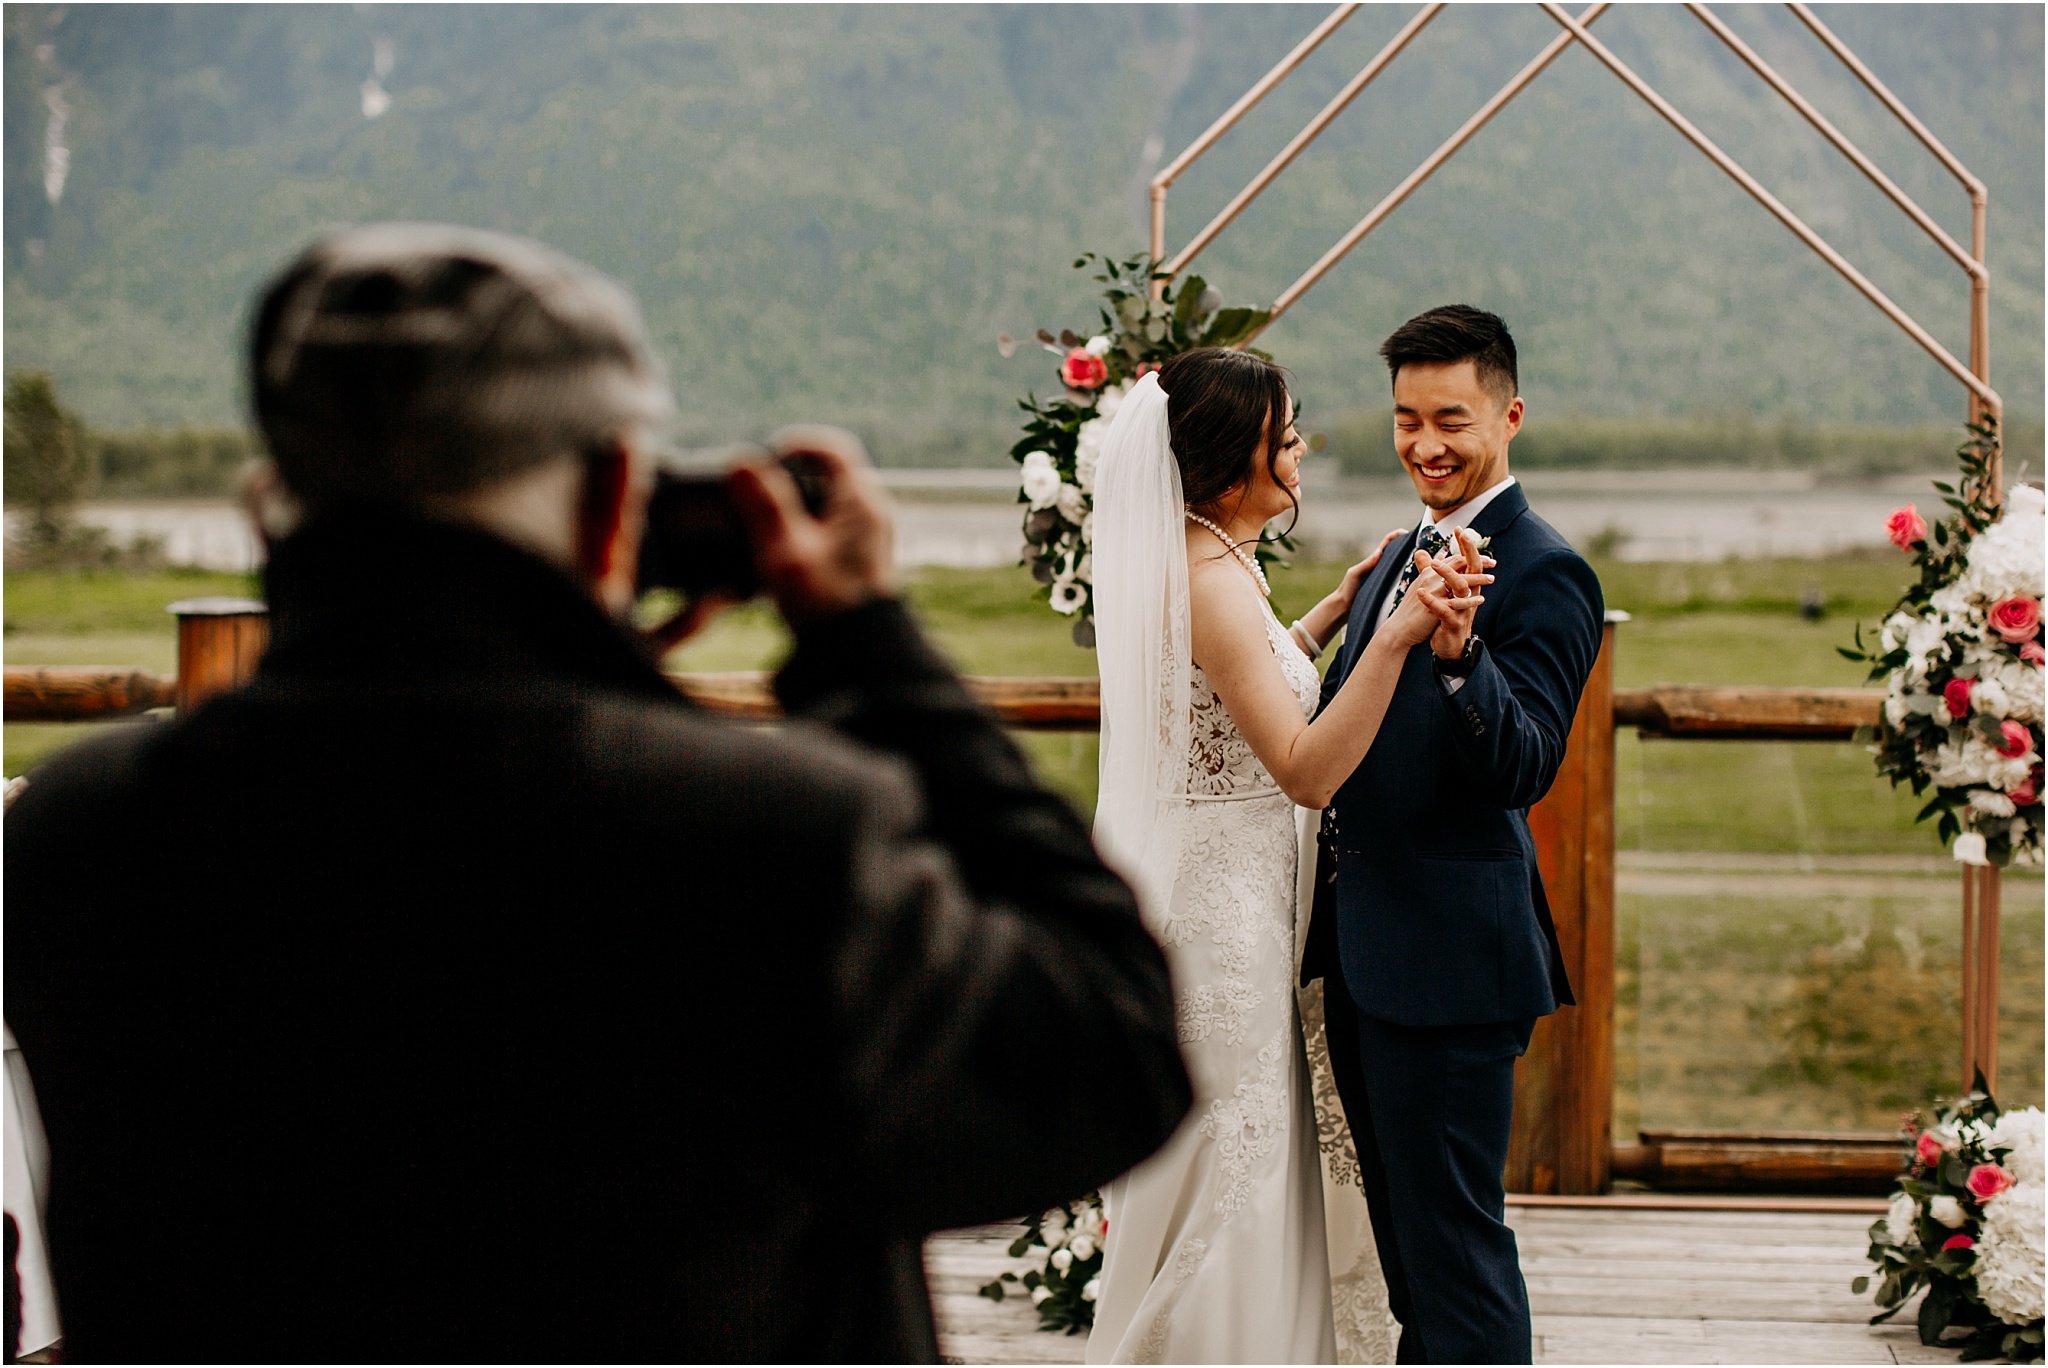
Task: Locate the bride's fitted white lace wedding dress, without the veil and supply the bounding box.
[1087,608,1395,1364]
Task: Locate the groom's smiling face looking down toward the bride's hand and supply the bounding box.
[1395,360,1522,512]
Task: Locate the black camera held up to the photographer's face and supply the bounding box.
[639,442,825,598]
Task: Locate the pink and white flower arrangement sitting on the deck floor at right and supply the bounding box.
[1849,1075,2048,1364]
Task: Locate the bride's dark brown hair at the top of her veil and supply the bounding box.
[1159,346,1300,530]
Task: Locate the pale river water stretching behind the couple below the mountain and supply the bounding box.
[8,469,1939,569]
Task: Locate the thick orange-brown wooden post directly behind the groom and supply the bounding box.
[1507,612,1628,1196]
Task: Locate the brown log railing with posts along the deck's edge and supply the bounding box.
[4,600,1898,1194]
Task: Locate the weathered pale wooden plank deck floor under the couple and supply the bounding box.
[926,1202,1956,1364]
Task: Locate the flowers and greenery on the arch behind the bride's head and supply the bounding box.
[997,252,1272,647]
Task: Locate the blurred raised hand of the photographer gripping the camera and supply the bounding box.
[731,424,899,627]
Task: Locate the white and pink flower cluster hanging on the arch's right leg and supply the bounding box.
[1841,422,2048,866]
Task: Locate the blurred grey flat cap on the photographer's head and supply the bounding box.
[250,223,674,504]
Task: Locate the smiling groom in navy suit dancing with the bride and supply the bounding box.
[1303,305,1604,1364]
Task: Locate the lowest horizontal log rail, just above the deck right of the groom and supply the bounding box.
[1614,1130,1905,1194]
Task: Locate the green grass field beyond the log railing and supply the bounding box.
[4,555,2044,1137]
